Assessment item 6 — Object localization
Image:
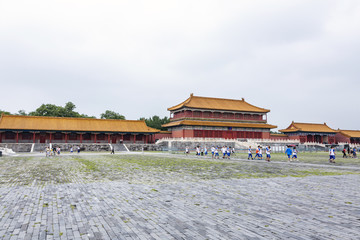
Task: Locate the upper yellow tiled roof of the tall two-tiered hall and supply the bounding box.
[168,94,270,113]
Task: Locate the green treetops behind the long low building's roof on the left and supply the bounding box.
[0,102,170,130]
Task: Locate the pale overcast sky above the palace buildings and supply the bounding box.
[0,0,360,129]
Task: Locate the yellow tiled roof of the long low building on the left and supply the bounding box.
[0,115,159,133]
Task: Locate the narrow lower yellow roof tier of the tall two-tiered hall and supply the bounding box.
[162,120,277,128]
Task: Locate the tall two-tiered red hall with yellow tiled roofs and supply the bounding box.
[163,94,276,139]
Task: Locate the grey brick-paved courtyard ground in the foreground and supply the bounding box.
[0,153,360,239]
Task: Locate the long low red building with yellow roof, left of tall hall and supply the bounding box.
[0,115,159,143]
